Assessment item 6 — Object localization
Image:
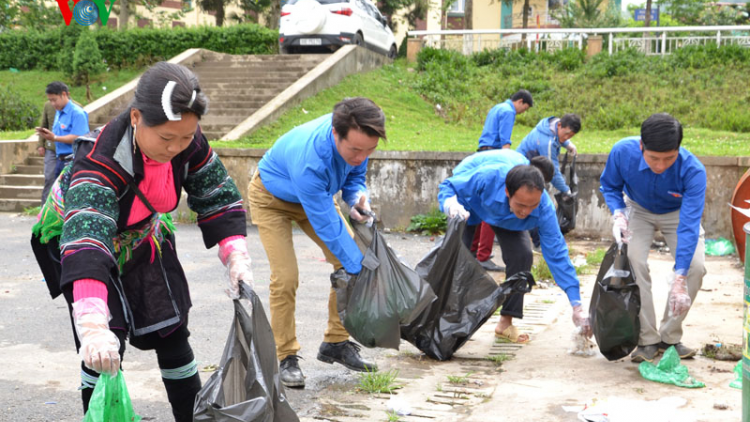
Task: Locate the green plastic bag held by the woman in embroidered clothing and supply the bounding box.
[83,371,141,422]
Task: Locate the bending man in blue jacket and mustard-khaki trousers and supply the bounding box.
[248,98,386,388]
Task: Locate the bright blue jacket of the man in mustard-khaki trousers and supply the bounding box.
[258,114,368,274]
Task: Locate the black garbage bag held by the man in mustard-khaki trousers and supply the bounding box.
[331,222,435,350]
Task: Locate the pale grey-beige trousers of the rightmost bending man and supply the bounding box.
[628,201,706,346]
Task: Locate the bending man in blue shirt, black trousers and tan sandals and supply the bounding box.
[438,161,591,343]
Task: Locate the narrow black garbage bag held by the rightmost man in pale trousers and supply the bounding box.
[589,243,641,360]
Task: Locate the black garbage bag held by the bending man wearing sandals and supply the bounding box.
[401,218,535,360]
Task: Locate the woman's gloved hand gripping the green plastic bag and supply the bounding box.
[73,297,120,375]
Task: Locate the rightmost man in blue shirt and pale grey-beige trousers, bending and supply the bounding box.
[600,113,706,362]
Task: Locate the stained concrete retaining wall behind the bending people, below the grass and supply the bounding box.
[216,149,750,238]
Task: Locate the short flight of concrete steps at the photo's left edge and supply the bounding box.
[0,156,44,212]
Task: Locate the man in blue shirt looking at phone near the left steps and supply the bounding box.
[36,81,89,178]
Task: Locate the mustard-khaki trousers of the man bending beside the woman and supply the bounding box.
[248,171,354,361]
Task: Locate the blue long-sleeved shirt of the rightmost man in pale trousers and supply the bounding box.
[599,136,706,275]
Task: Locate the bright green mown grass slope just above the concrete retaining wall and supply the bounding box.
[211,61,750,156]
